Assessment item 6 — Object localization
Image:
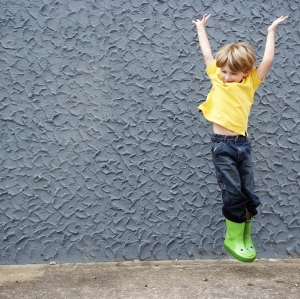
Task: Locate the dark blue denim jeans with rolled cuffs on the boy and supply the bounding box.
[211,134,260,223]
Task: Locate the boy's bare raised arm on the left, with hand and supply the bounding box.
[192,14,214,66]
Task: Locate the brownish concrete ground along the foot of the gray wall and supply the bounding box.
[0,259,300,299]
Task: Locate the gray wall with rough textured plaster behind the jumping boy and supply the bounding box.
[0,0,300,264]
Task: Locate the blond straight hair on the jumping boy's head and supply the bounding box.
[216,43,256,72]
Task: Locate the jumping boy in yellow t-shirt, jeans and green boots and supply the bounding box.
[193,14,287,262]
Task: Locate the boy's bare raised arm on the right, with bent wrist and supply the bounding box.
[256,16,288,80]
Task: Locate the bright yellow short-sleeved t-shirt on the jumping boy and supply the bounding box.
[198,60,262,135]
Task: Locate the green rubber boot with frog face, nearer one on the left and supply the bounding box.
[224,219,255,263]
